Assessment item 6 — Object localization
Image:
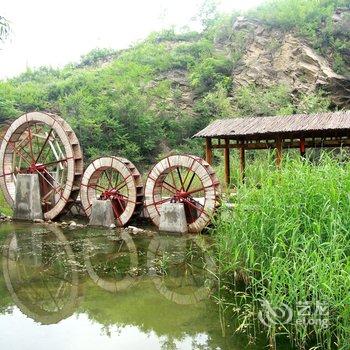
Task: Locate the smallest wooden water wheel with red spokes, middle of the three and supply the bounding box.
[80,157,143,226]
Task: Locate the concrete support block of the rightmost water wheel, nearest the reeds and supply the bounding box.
[159,203,188,233]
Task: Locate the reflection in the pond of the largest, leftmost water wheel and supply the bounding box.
[2,227,79,324]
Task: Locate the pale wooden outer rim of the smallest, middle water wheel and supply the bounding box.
[80,156,143,226]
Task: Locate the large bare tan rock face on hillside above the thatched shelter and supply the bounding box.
[232,17,350,107]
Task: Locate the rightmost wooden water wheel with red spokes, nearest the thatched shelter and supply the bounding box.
[145,155,220,232]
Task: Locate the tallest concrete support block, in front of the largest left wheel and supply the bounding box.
[13,174,44,220]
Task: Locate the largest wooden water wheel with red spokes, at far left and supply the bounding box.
[0,112,84,220]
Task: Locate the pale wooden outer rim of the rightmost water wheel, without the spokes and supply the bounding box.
[145,155,220,232]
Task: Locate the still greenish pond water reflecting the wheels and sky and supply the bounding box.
[0,223,266,350]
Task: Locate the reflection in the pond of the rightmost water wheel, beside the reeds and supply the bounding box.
[147,236,216,305]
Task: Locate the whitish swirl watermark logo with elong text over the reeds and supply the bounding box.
[258,300,329,329]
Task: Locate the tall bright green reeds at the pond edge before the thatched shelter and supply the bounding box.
[214,154,350,349]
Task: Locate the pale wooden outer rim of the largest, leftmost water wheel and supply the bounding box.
[0,112,83,220]
